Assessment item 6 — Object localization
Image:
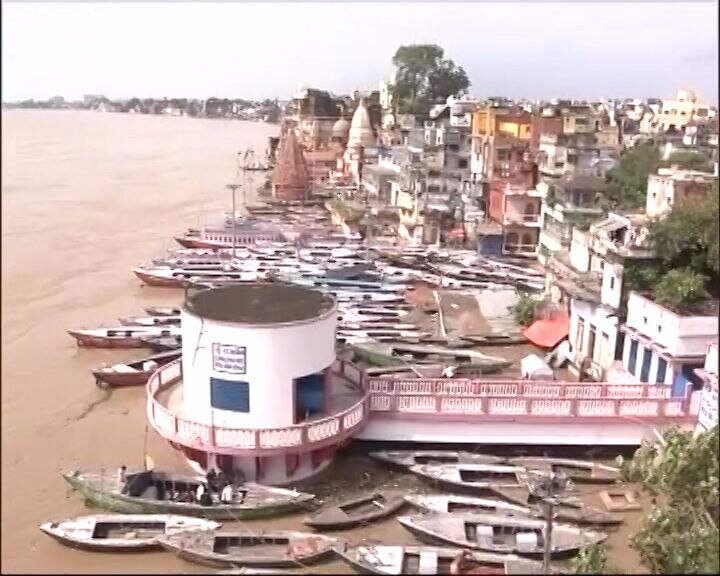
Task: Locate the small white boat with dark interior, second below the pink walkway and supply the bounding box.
[408,464,526,495]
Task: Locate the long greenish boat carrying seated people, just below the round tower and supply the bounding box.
[63,470,315,520]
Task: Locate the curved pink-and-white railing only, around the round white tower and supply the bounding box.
[147,359,369,455]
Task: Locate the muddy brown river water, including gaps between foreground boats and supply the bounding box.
[2,111,639,574]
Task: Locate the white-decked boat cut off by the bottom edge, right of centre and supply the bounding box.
[336,546,555,574]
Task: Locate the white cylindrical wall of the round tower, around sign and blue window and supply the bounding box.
[182,310,337,428]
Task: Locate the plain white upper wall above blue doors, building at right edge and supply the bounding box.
[626,292,718,356]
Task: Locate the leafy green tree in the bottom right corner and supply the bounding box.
[622,425,720,574]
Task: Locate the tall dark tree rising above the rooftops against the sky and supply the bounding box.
[393,44,470,114]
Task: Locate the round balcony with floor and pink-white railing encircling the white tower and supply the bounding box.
[147,360,368,456]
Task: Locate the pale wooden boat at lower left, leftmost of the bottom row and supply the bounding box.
[40,514,220,552]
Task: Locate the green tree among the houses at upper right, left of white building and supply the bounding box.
[604,142,660,210]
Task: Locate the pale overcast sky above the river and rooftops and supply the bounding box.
[2,1,718,104]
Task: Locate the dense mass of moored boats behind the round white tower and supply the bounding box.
[68,197,543,386]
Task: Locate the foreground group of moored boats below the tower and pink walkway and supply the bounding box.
[41,450,623,574]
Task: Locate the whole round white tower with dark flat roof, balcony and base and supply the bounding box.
[148,284,365,484]
